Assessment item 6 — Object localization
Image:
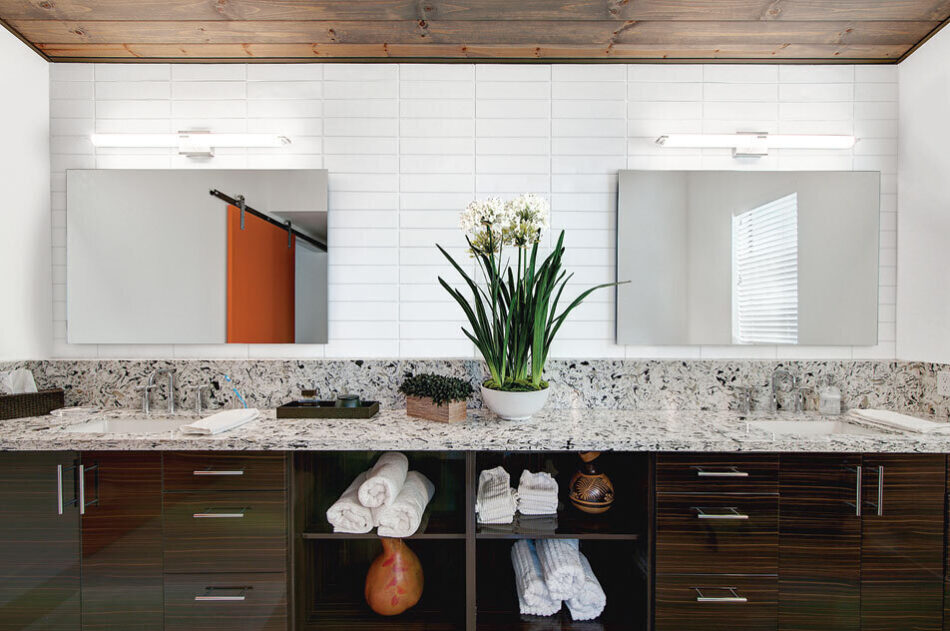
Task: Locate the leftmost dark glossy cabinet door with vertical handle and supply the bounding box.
[0,452,80,631]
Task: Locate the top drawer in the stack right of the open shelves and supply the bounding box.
[656,454,778,493]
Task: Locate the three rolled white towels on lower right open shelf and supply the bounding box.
[511,539,607,620]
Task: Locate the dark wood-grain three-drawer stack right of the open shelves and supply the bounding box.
[654,454,779,631]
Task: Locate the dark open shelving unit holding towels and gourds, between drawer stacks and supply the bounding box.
[293,451,653,631]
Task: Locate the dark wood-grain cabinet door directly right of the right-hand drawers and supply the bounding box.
[779,454,861,631]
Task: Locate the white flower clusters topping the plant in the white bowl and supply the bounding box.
[459,193,550,252]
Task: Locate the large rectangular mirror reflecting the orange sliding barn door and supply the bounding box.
[66,169,327,344]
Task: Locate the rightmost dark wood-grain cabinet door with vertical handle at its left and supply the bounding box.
[861,454,946,631]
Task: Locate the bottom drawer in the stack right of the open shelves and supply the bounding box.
[656,575,778,631]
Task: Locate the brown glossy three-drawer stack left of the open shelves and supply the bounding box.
[162,452,289,631]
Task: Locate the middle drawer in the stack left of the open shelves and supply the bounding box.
[164,491,287,572]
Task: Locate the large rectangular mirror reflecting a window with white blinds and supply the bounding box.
[617,171,880,346]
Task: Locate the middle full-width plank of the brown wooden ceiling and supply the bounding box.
[12,20,939,47]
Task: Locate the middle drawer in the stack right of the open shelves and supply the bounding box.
[656,493,778,574]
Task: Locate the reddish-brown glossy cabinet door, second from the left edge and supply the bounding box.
[82,452,163,631]
